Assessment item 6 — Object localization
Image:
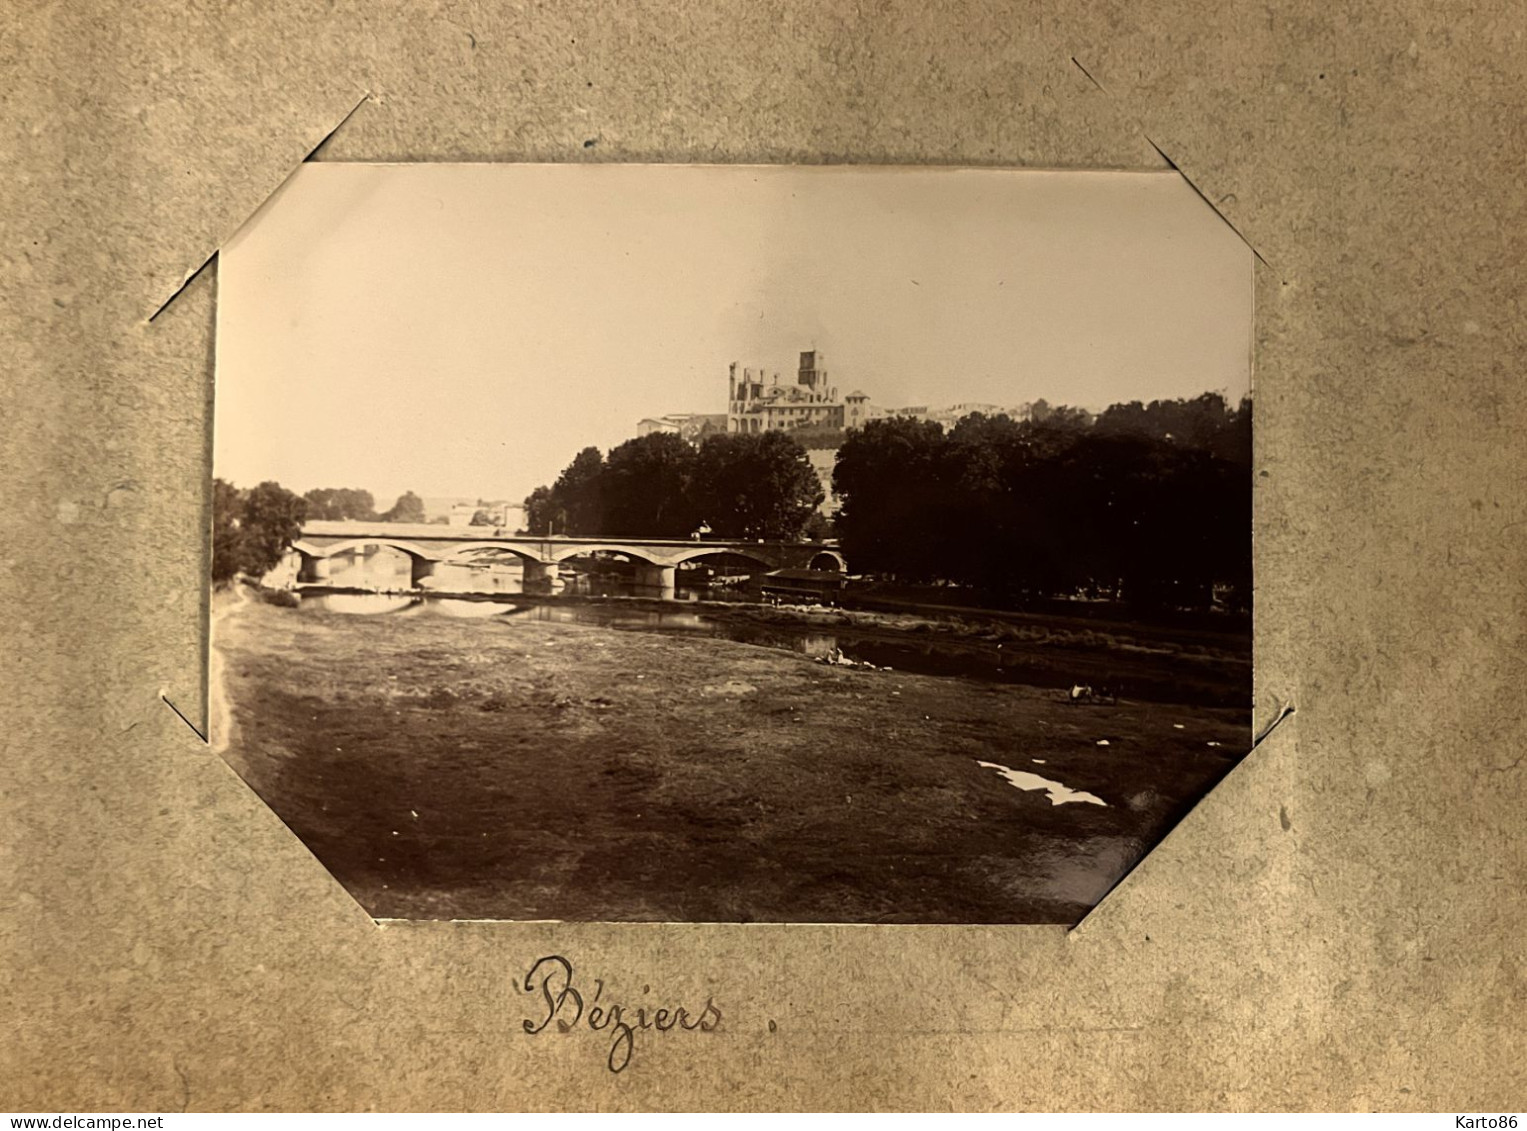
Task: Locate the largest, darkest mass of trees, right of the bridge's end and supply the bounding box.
[834,394,1251,607]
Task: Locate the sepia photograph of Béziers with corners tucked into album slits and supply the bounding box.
[209,162,1254,923]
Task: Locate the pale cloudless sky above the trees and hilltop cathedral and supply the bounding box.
[214,162,1252,508]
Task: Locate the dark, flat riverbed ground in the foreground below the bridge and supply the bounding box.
[214,586,1249,923]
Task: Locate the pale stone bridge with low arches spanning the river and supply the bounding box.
[292,520,844,598]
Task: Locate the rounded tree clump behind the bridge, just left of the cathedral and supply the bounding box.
[525,432,825,539]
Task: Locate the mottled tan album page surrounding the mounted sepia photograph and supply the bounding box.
[0,2,1527,1111]
